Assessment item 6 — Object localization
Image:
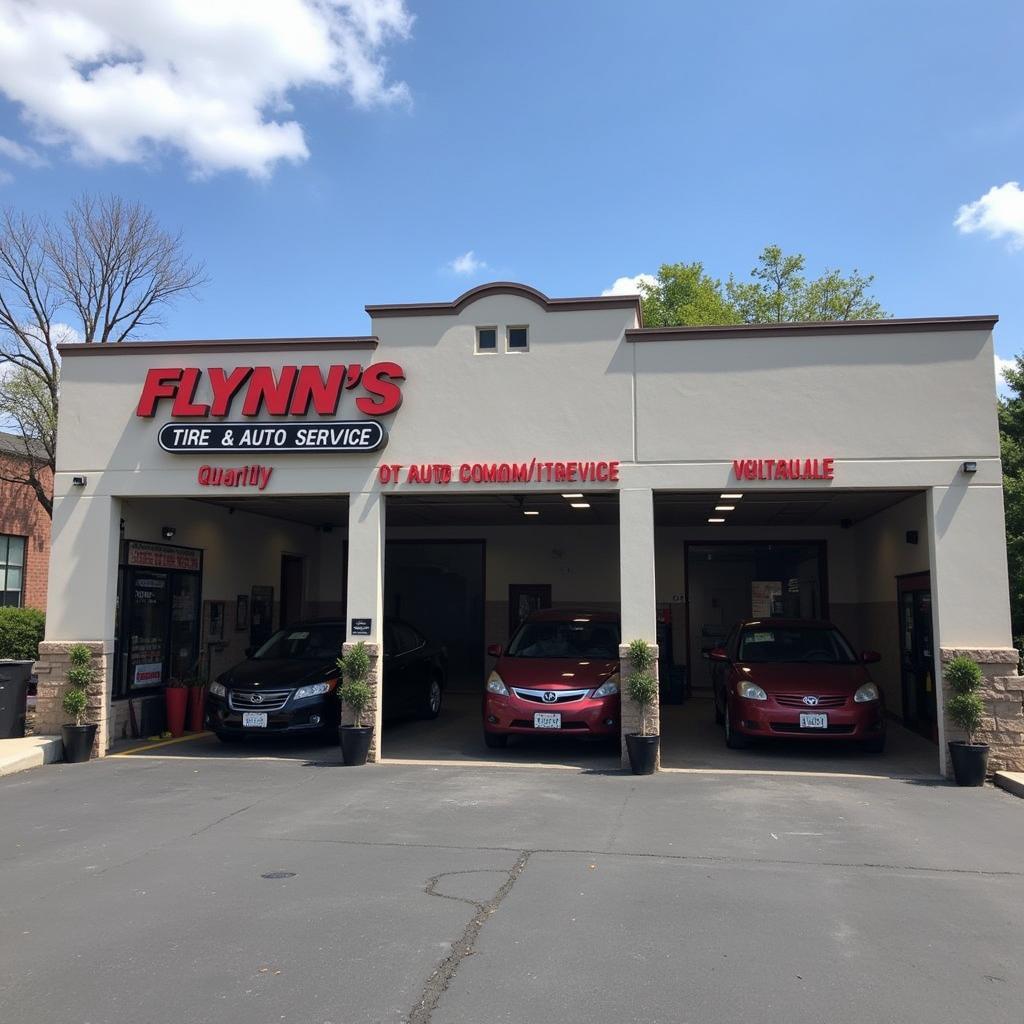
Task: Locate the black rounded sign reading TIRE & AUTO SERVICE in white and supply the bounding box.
[157,420,387,453]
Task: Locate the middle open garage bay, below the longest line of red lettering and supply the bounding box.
[382,494,618,767]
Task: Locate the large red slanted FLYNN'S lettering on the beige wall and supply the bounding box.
[135,362,406,419]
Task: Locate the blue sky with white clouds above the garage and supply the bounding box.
[0,0,1024,387]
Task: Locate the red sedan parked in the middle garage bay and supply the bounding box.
[483,608,620,746]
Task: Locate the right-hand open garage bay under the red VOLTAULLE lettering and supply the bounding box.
[654,489,938,775]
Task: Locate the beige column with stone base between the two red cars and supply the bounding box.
[618,487,660,767]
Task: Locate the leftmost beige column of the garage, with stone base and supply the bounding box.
[36,492,121,757]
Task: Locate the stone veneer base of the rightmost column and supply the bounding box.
[940,647,1024,778]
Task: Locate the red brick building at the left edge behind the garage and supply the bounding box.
[0,432,53,609]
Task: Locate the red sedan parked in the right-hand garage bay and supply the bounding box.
[709,618,886,753]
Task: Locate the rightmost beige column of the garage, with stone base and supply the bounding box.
[928,483,1024,773]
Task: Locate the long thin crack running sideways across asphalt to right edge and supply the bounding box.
[259,836,1024,879]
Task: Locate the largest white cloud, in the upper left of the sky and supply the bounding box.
[0,0,413,177]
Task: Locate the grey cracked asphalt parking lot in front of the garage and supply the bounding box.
[0,746,1024,1024]
